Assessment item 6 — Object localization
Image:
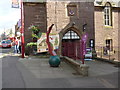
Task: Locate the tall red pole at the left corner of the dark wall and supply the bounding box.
[21,0,25,58]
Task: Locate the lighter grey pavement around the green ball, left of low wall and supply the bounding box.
[19,57,81,78]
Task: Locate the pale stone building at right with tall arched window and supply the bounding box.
[94,0,120,61]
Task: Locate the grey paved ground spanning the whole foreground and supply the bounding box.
[2,49,118,88]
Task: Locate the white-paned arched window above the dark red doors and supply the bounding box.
[63,30,80,39]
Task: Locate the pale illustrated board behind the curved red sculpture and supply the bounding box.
[37,33,59,53]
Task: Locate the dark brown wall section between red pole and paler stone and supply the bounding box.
[24,3,47,44]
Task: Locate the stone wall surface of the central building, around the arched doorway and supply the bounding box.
[24,2,95,54]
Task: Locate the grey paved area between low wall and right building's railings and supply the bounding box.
[85,60,118,76]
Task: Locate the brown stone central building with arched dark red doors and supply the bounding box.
[23,0,95,58]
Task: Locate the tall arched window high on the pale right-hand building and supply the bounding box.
[104,3,112,26]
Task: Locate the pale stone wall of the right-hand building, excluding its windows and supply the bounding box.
[95,7,119,60]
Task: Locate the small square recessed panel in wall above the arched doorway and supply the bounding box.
[67,5,77,16]
